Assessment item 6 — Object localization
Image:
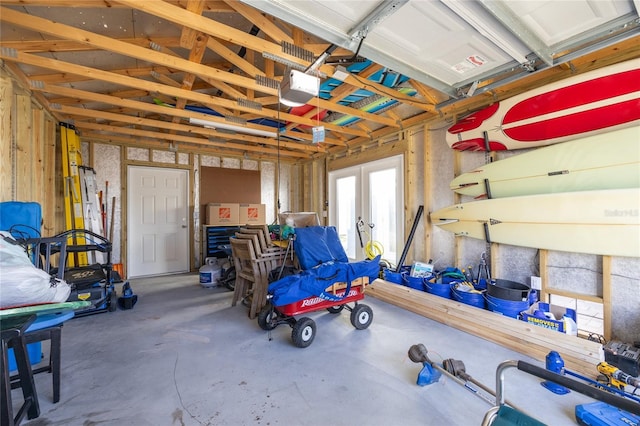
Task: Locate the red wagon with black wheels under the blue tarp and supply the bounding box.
[258,277,373,348]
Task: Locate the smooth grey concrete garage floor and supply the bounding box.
[12,274,591,426]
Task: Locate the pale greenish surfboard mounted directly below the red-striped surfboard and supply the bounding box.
[450,127,640,198]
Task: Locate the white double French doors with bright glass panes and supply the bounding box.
[329,155,404,263]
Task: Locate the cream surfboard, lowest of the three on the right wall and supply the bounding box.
[430,188,640,257]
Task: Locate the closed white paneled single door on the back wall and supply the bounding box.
[127,166,189,277]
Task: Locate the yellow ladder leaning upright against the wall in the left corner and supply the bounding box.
[60,123,89,266]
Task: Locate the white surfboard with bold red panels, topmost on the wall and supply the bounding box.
[446,59,640,151]
